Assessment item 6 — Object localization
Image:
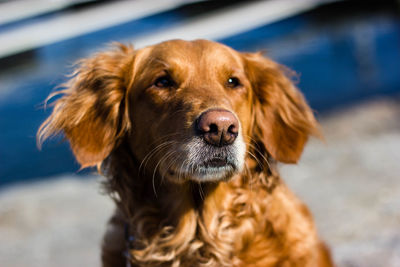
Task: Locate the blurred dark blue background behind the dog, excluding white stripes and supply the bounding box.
[0,1,400,187]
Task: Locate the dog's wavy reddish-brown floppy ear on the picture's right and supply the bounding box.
[244,53,320,163]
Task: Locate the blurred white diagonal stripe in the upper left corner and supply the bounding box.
[0,0,184,58]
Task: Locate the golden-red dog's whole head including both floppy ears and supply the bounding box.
[39,40,318,182]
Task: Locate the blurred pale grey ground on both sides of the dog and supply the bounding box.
[0,98,400,267]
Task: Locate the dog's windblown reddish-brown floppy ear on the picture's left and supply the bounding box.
[38,45,134,168]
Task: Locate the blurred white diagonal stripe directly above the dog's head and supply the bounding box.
[129,0,321,48]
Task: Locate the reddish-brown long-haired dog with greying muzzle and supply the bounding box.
[38,40,332,267]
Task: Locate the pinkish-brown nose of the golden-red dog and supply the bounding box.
[196,109,239,147]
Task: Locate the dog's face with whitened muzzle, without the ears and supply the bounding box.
[128,41,252,181]
